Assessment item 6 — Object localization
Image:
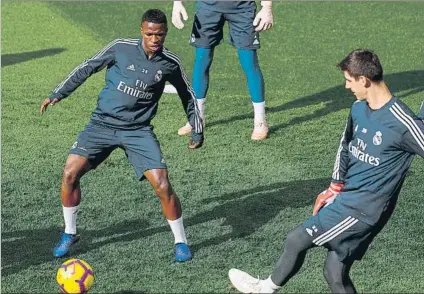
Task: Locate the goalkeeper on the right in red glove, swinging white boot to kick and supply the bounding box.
[229,50,424,293]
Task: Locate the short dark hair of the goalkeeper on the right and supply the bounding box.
[337,49,383,82]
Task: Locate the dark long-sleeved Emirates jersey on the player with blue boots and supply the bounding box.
[50,38,203,133]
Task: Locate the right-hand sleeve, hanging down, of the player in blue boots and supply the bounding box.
[169,64,203,134]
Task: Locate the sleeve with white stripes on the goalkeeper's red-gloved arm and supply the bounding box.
[331,110,353,183]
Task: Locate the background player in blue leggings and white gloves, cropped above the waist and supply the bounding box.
[172,1,273,140]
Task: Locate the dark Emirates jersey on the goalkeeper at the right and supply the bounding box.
[332,97,424,225]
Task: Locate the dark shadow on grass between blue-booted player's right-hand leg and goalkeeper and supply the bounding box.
[184,179,329,252]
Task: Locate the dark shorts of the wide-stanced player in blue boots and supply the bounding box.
[69,122,166,180]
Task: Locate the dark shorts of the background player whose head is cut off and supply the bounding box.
[190,9,260,50]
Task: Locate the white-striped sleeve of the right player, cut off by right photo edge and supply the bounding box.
[402,116,424,158]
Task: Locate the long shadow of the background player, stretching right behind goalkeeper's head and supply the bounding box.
[207,70,424,133]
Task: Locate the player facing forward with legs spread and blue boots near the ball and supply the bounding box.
[40,9,203,262]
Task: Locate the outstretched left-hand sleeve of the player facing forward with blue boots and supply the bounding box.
[49,40,117,100]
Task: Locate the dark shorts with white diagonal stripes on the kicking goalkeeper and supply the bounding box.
[302,201,385,262]
